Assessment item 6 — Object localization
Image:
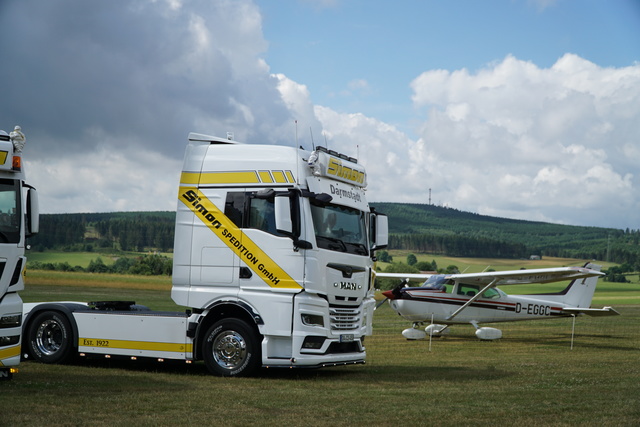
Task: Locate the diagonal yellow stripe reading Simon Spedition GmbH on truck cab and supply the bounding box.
[178,187,302,289]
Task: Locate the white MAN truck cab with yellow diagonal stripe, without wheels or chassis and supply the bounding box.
[172,134,387,374]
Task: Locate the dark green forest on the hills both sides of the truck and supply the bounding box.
[29,203,640,270]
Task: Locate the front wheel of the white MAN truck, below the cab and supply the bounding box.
[202,319,262,377]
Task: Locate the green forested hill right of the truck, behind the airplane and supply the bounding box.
[372,203,640,265]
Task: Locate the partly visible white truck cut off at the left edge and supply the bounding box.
[0,126,38,379]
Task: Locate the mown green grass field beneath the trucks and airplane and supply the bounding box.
[6,256,640,426]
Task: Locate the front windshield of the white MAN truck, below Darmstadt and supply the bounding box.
[311,202,369,255]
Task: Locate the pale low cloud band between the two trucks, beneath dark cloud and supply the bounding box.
[25,146,182,213]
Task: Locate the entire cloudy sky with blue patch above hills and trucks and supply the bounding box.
[0,0,640,229]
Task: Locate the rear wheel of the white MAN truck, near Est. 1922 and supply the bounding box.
[27,311,73,363]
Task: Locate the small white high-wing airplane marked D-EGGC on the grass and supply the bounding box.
[376,263,619,340]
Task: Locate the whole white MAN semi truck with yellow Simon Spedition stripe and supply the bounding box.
[23,133,388,376]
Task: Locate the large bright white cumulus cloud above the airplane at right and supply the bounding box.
[400,54,640,226]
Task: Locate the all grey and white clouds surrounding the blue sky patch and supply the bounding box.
[0,0,640,228]
